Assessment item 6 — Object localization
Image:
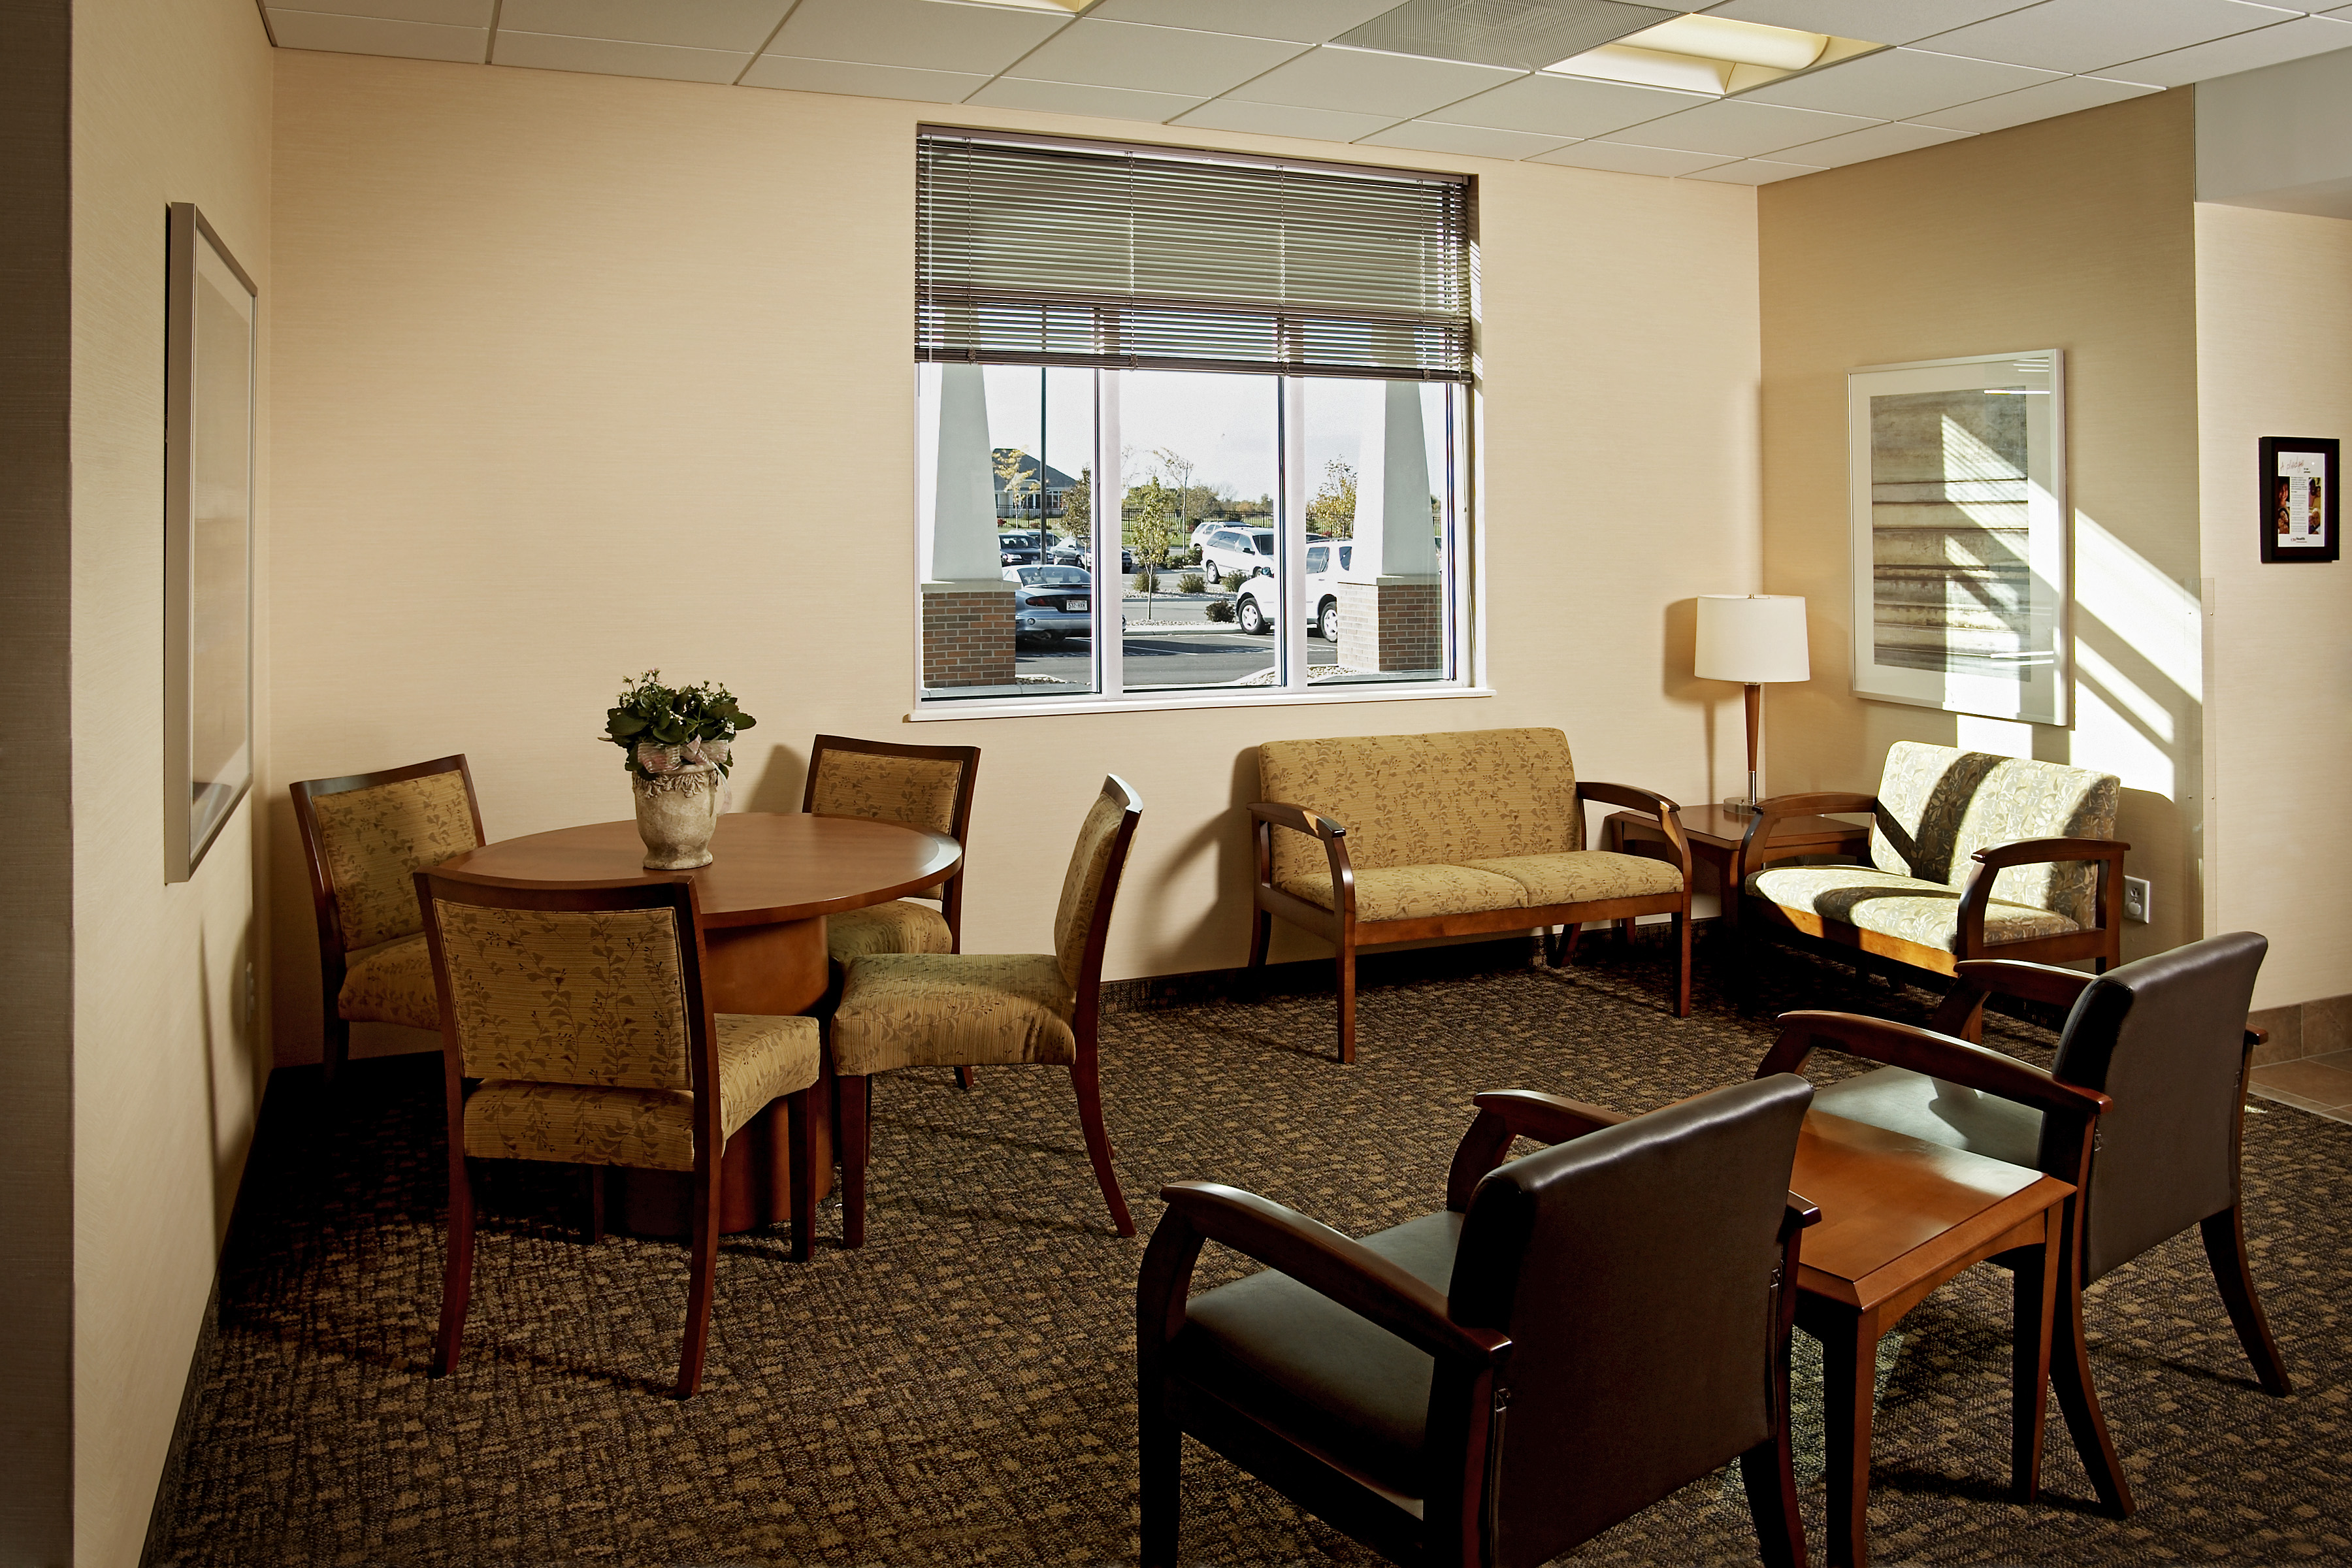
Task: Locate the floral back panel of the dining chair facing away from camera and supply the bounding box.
[416,870,717,1091]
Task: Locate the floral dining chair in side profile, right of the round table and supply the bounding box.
[828,774,1143,1246]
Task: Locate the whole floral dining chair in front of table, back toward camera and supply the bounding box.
[416,870,823,1399]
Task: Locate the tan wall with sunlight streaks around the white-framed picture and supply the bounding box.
[1757,91,2202,956]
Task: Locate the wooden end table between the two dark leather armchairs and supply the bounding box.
[1788,1109,2074,1568]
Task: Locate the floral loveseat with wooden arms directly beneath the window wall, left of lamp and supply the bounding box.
[1249,728,1691,1062]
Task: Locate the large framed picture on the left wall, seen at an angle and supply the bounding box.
[162,202,261,881]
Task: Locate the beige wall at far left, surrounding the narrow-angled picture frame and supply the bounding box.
[73,0,273,1563]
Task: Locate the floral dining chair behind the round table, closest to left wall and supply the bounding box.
[291,755,482,1084]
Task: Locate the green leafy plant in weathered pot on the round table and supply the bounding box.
[604,670,755,872]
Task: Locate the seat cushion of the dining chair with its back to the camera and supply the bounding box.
[466,1013,821,1171]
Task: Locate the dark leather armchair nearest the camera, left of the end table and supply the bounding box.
[1136,1077,1818,1568]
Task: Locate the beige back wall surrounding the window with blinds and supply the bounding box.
[268,52,1757,1060]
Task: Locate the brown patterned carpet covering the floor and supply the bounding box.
[148,943,2352,1568]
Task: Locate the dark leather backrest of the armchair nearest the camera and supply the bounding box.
[1432,1074,1814,1568]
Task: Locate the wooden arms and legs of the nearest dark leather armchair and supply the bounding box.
[1136,1088,1820,1568]
